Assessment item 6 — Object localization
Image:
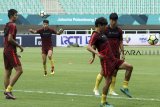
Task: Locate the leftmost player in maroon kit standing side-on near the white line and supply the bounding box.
[3,9,23,99]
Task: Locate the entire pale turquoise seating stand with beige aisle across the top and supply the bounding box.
[0,0,160,14]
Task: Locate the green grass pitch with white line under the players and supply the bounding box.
[0,47,160,107]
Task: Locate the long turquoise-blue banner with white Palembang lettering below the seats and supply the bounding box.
[0,14,160,25]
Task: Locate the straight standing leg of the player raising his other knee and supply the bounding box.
[100,76,113,107]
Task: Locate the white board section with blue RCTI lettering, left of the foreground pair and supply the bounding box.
[56,34,91,47]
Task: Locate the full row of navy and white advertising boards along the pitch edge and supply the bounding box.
[0,34,160,47]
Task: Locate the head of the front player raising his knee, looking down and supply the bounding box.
[95,17,108,31]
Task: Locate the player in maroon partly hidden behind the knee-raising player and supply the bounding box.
[92,13,126,95]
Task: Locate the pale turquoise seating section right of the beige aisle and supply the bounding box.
[59,0,160,14]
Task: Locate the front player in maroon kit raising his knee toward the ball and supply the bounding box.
[87,17,133,107]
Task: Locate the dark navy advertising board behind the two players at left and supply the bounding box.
[0,35,56,47]
